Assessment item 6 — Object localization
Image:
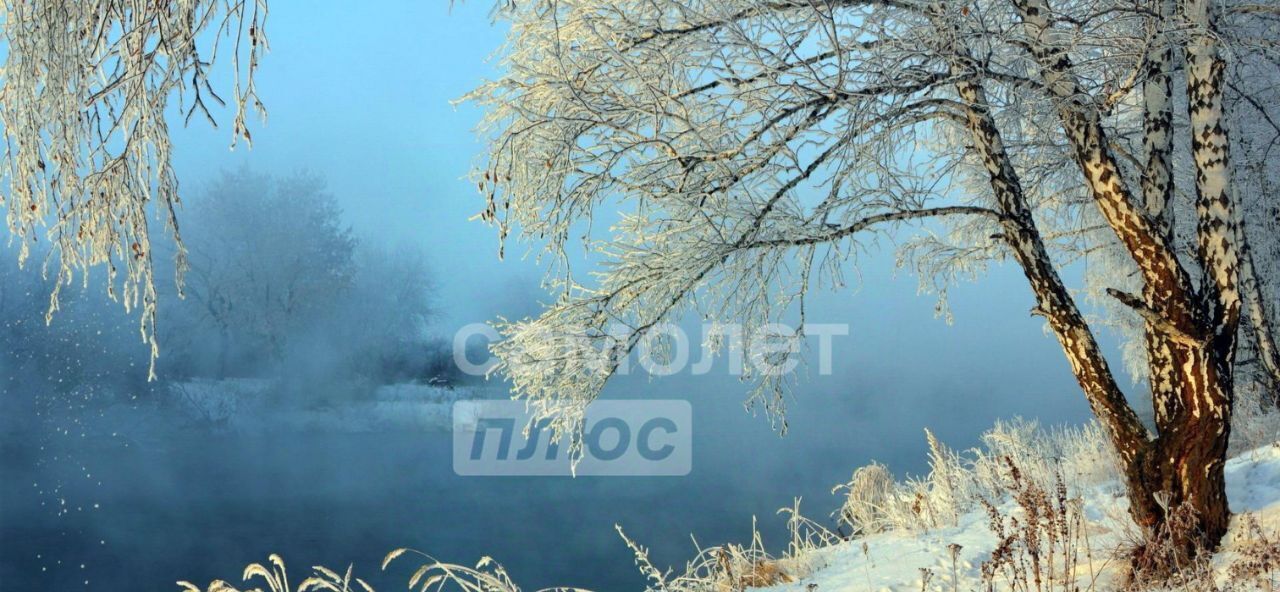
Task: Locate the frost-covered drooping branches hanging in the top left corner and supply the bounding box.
[0,0,268,373]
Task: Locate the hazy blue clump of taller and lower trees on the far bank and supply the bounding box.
[160,169,442,391]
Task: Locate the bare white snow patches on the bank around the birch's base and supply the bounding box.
[764,442,1280,592]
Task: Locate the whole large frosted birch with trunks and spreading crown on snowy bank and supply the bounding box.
[470,0,1280,552]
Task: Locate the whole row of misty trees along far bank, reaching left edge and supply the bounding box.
[0,169,452,396]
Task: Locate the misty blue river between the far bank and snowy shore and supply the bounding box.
[0,363,1095,591]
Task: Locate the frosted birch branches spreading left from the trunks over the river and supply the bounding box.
[472,3,1013,435]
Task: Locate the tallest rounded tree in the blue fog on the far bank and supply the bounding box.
[175,170,356,375]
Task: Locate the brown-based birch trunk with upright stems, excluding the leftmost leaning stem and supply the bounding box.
[1015,0,1240,556]
